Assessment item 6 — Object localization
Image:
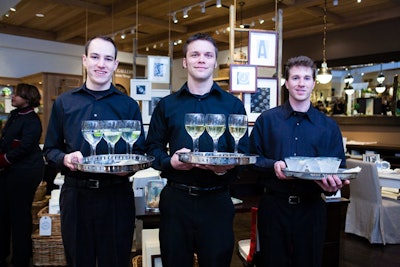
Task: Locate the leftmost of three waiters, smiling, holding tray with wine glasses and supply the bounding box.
[44,36,145,267]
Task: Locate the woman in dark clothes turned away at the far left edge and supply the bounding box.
[0,83,44,267]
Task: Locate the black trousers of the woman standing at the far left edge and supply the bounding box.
[0,168,43,267]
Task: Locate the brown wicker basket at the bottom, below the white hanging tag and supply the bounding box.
[32,231,67,266]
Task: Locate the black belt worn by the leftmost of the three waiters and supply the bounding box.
[64,176,129,189]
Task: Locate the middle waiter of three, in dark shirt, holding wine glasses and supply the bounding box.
[146,33,248,267]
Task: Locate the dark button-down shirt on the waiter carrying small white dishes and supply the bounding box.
[250,102,346,194]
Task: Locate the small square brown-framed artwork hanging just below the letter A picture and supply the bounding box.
[229,64,257,93]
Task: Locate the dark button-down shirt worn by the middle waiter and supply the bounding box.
[146,83,248,186]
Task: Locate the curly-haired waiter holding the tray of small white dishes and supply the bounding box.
[250,56,349,267]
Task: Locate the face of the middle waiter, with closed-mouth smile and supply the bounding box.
[183,40,217,82]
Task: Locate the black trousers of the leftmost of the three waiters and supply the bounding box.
[60,181,135,267]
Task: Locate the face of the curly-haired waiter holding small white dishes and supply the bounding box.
[285,66,315,112]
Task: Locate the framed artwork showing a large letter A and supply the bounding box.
[248,31,277,68]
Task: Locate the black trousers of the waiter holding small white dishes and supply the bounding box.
[257,194,326,267]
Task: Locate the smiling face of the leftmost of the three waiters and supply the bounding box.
[82,38,118,91]
